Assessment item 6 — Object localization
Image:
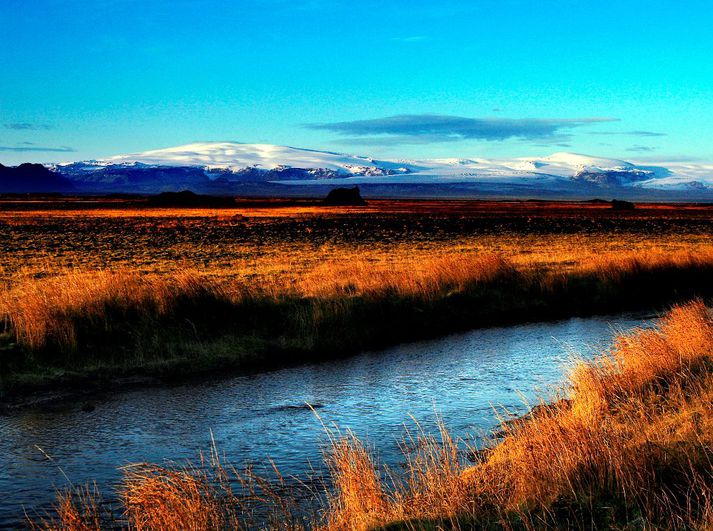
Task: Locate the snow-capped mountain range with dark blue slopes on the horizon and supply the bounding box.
[40,142,713,197]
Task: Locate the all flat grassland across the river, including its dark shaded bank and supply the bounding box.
[0,200,713,399]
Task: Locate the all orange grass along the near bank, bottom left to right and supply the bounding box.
[36,301,713,530]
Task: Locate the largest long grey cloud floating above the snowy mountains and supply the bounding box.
[305,114,618,144]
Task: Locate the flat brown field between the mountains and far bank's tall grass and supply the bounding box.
[0,200,713,285]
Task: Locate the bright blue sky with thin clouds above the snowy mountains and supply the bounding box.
[0,0,713,164]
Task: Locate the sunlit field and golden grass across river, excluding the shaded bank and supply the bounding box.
[0,201,713,358]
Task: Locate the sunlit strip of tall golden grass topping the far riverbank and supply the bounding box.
[0,251,713,358]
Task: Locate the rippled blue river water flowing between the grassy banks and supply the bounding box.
[0,314,651,527]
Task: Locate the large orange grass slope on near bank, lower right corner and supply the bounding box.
[322,302,713,529]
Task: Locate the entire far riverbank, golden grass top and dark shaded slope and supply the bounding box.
[0,253,713,404]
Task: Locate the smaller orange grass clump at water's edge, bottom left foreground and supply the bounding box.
[37,446,306,531]
